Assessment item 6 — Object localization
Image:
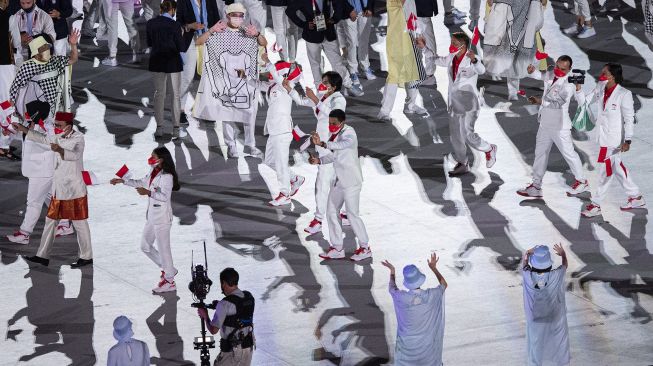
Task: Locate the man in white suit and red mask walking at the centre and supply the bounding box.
[309,109,372,261]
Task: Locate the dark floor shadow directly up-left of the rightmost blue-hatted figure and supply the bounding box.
[456,172,522,271]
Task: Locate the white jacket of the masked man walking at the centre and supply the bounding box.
[320,125,363,188]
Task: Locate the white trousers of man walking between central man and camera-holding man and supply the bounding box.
[449,111,492,164]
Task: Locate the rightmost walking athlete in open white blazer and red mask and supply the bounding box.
[577,63,646,217]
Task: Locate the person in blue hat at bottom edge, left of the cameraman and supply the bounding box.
[107,315,150,366]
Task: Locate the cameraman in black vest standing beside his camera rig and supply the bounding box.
[197,268,254,366]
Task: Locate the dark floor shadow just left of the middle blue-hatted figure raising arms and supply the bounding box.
[313,240,390,366]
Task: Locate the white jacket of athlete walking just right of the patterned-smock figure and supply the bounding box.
[263,63,293,136]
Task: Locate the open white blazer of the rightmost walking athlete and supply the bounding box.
[576,82,635,148]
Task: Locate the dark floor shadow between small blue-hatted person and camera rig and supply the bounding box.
[146,292,194,366]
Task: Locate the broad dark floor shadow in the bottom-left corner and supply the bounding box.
[7,265,96,366]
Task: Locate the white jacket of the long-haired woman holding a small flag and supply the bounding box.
[125,169,173,224]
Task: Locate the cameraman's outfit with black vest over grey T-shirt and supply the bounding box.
[211,289,255,366]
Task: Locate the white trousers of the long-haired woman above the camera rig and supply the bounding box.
[141,220,177,282]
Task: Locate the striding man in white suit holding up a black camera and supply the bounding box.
[517,55,589,198]
